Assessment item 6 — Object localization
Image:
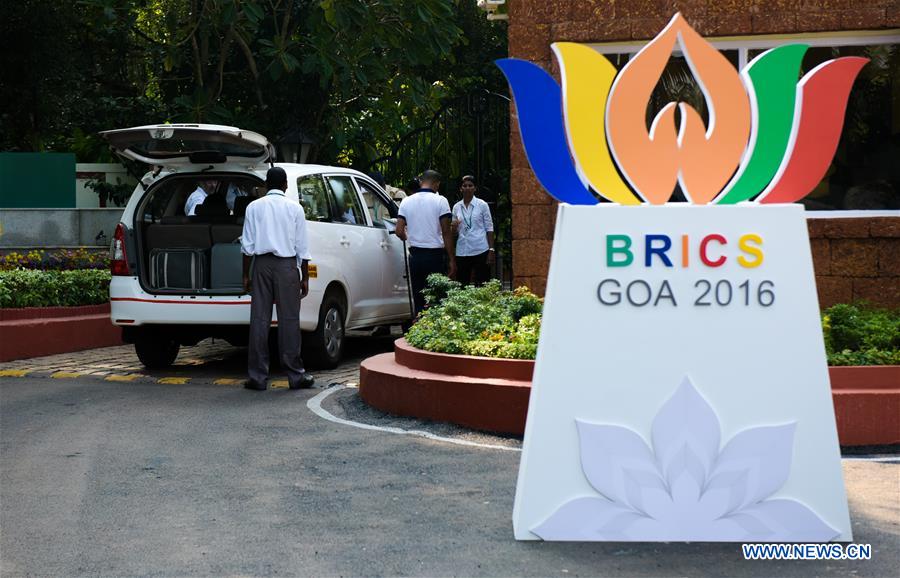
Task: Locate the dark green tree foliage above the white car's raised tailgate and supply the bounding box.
[0,0,505,164]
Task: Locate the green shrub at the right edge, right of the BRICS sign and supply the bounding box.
[822,303,900,365]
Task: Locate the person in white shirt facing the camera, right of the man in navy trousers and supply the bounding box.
[450,175,494,285]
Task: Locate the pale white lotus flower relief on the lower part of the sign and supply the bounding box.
[531,378,840,542]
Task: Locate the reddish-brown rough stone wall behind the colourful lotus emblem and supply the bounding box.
[509,0,900,307]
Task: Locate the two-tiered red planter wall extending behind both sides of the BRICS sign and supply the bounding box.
[359,339,900,446]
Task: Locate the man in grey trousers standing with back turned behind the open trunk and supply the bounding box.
[241,167,315,391]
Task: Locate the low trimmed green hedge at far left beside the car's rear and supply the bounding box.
[0,269,110,308]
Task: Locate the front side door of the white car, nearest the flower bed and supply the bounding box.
[354,176,411,318]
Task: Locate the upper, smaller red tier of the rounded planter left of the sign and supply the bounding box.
[394,337,534,381]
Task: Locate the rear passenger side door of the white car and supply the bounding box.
[324,173,385,328]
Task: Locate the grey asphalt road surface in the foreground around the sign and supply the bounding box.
[0,377,900,576]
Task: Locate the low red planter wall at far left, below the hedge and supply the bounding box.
[0,303,122,361]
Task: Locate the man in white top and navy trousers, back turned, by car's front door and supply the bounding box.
[396,170,456,315]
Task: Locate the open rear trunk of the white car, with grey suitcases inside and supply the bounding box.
[134,173,264,295]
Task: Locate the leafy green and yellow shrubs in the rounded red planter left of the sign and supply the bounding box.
[406,275,543,359]
